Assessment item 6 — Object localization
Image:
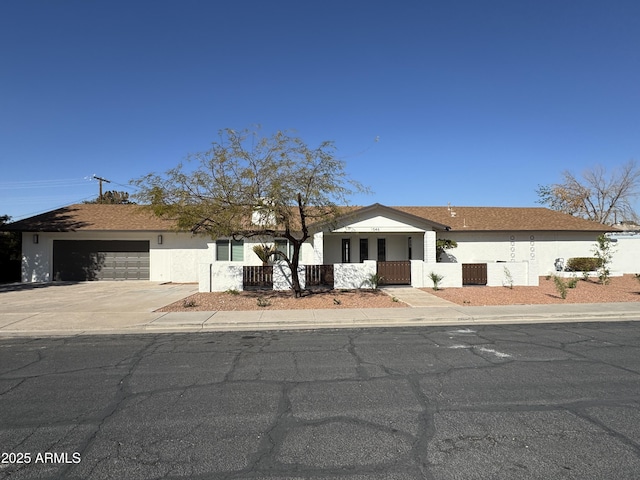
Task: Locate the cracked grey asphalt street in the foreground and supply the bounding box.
[0,322,640,480]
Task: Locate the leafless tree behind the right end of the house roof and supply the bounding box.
[536,160,640,225]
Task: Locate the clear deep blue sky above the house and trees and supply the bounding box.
[0,0,640,219]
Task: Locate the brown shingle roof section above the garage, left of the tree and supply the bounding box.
[5,204,175,232]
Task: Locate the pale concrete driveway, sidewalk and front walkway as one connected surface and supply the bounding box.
[0,282,640,337]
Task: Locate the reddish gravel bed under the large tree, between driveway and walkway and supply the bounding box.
[157,290,408,312]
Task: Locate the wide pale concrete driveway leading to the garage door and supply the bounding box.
[0,281,198,332]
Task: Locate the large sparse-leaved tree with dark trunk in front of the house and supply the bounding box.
[134,129,367,297]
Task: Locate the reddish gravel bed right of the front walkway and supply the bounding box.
[423,275,640,306]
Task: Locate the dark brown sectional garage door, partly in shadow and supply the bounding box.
[53,240,149,281]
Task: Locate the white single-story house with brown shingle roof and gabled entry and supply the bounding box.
[5,204,624,290]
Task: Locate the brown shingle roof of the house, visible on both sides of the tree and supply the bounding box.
[4,204,618,232]
